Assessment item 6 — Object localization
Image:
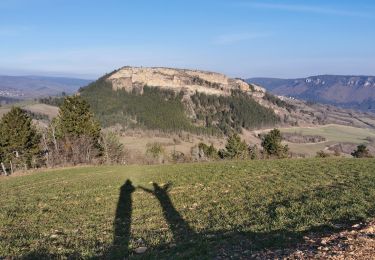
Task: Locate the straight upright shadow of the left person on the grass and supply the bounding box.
[109,180,135,259]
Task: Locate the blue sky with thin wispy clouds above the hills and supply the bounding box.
[0,0,375,79]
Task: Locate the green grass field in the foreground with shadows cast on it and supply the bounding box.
[0,159,375,259]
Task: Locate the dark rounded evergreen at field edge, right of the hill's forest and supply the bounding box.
[262,128,289,158]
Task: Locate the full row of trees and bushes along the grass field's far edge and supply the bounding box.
[0,93,371,175]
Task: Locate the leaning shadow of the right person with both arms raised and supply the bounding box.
[139,183,195,242]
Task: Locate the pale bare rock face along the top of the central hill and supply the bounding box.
[108,67,251,95]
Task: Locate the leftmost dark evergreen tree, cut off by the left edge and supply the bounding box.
[0,107,41,168]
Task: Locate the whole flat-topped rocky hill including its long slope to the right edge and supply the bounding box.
[79,67,375,135]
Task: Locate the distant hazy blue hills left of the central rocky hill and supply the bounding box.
[0,76,91,99]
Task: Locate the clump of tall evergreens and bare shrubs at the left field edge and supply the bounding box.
[0,96,124,174]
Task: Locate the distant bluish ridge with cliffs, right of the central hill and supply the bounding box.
[247,75,375,111]
